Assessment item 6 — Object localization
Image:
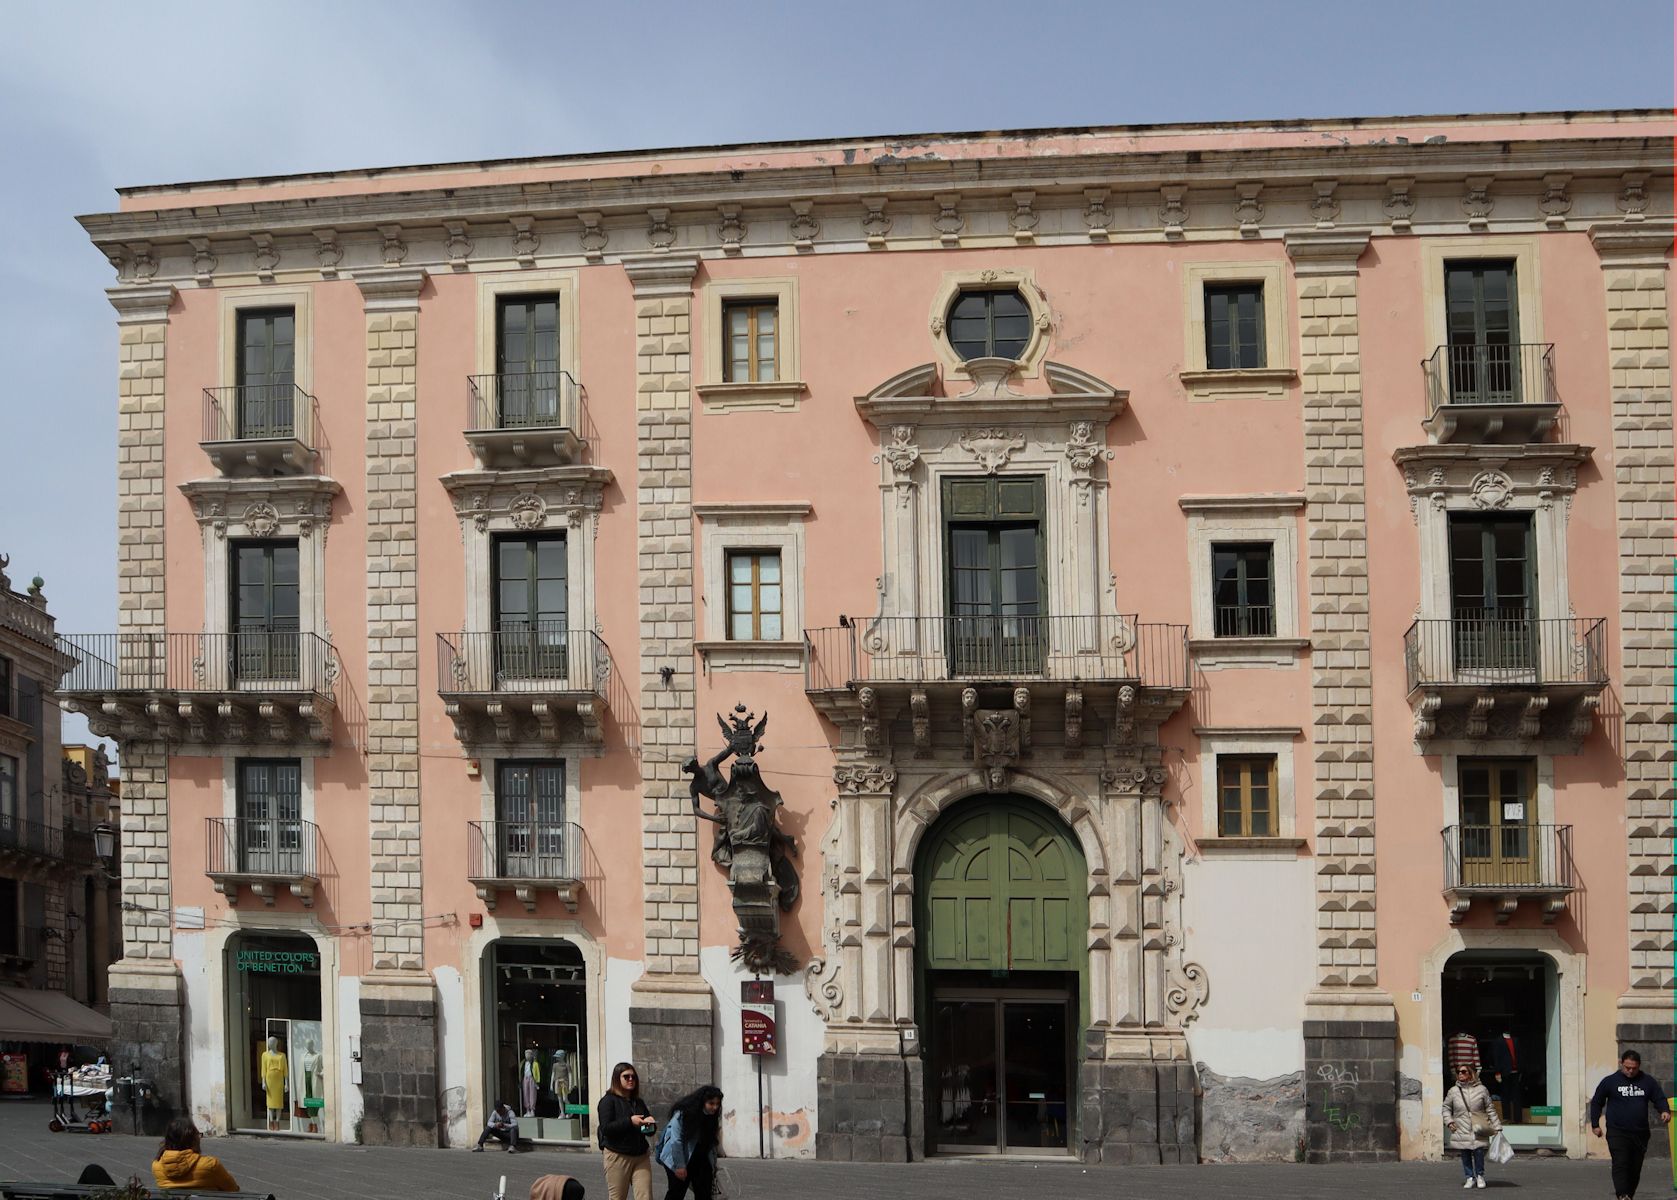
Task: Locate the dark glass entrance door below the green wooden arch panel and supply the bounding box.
[926,991,1072,1155]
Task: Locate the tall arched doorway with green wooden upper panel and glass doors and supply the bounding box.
[916,796,1088,1153]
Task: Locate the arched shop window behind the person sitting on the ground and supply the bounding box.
[485,939,592,1143]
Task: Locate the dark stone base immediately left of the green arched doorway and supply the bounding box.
[815,1054,926,1163]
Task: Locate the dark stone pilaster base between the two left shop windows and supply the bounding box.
[361,989,443,1146]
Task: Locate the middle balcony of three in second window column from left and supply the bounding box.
[436,623,610,747]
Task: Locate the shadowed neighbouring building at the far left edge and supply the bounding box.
[0,555,117,1089]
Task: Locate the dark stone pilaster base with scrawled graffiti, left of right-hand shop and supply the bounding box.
[1305,1021,1397,1163]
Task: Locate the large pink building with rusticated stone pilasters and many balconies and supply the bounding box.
[62,112,1674,1163]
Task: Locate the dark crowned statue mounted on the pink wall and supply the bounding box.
[683,704,800,975]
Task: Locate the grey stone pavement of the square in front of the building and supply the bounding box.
[0,1101,1636,1200]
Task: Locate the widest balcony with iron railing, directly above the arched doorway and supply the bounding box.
[803,615,1189,753]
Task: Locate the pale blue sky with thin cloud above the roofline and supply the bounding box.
[0,0,1672,750]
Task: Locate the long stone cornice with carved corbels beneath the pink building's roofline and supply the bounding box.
[82,139,1670,288]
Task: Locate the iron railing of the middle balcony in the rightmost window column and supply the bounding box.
[1404,612,1607,691]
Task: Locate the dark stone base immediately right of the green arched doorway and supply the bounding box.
[1077,1059,1199,1166]
